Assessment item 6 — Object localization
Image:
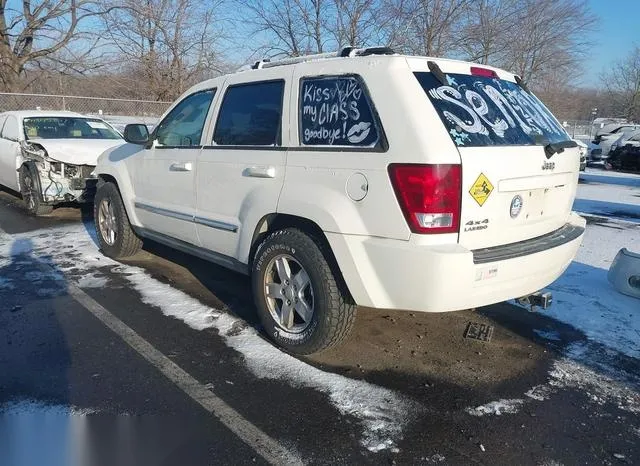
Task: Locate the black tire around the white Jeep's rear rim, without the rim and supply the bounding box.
[251,228,356,354]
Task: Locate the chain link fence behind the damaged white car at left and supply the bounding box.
[0,92,171,127]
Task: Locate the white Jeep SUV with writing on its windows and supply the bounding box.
[95,48,585,354]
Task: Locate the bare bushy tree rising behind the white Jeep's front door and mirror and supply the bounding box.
[104,0,225,100]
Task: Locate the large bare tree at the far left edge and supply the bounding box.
[0,0,105,91]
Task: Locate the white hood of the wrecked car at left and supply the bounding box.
[28,139,125,166]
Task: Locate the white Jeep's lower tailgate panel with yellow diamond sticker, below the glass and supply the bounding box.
[459,146,579,249]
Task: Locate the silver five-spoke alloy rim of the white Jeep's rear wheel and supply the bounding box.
[264,254,315,333]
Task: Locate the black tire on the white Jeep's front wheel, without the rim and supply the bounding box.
[93,182,142,259]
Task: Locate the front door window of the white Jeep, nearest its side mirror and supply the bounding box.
[155,89,216,147]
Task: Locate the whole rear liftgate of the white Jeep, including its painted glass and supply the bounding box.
[415,62,580,249]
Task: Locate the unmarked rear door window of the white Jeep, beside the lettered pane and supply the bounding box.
[213,81,284,146]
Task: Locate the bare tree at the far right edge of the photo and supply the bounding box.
[602,45,640,121]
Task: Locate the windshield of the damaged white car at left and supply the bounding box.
[23,117,122,140]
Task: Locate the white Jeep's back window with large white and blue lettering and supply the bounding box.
[415,72,570,147]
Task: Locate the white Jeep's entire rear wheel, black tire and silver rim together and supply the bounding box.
[251,228,356,354]
